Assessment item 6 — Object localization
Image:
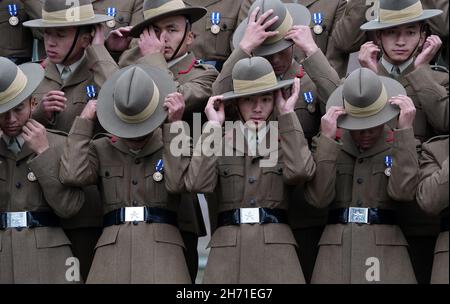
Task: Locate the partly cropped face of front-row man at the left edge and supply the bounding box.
[0,98,34,137]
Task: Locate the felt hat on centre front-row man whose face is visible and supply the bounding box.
[223,57,294,100]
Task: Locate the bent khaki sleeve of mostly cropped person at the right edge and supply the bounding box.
[416,144,449,215]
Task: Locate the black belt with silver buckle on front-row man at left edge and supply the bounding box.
[0,212,61,230]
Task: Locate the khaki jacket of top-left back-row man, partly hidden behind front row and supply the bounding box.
[33,46,117,228]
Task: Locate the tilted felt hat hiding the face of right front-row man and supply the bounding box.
[327,68,406,130]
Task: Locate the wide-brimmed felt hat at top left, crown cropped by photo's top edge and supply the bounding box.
[23,0,114,28]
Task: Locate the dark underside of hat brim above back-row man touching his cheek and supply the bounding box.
[130,6,208,38]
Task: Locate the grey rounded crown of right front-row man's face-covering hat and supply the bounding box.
[342,68,383,108]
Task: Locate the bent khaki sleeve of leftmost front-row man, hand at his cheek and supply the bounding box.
[29,136,85,218]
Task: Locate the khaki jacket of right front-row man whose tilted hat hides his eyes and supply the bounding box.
[305,129,417,284]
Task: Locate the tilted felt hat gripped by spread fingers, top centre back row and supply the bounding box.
[233,0,311,56]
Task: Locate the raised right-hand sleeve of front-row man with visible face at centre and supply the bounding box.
[278,113,316,185]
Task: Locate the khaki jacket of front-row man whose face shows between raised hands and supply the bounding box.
[186,113,315,284]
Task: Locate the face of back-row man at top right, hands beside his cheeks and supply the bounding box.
[377,23,425,65]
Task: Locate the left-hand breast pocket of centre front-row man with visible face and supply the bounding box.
[219,164,244,202]
